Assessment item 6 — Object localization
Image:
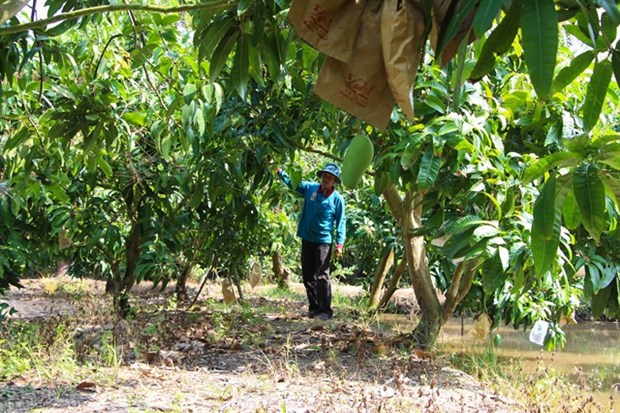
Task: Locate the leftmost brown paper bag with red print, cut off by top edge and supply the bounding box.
[288,0,365,62]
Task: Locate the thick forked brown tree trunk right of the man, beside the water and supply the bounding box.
[383,185,442,348]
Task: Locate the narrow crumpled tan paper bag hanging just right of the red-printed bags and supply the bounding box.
[381,0,425,120]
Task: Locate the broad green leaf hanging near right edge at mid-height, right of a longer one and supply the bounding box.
[573,164,605,241]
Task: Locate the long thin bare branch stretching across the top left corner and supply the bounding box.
[0,0,234,36]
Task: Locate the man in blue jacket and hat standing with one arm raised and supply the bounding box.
[277,163,346,320]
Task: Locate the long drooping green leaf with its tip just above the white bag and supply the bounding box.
[531,175,561,277]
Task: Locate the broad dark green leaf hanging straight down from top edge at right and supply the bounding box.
[521,0,558,98]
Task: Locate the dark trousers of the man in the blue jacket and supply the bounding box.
[301,240,333,317]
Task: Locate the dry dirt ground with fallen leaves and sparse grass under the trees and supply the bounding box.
[0,280,527,413]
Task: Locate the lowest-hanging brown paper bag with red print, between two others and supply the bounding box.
[314,0,394,129]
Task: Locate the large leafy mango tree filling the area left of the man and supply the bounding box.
[2,0,294,314]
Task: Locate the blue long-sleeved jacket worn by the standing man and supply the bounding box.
[278,170,346,245]
